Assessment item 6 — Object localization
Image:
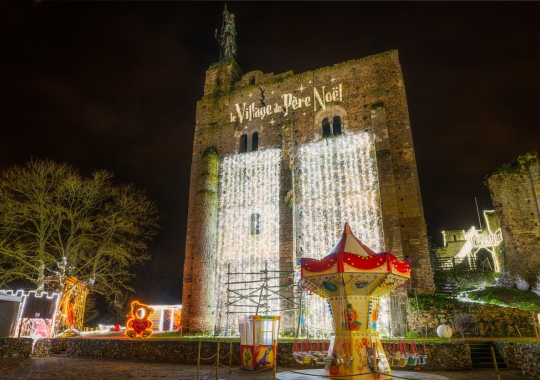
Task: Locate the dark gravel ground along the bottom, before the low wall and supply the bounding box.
[0,357,526,380]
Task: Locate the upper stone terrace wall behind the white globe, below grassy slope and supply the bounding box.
[409,300,535,337]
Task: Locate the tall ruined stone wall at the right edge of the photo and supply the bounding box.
[487,155,540,284]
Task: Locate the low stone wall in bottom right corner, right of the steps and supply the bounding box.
[494,342,540,379]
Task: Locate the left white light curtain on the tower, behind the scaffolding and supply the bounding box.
[216,149,281,331]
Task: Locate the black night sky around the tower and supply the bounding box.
[0,0,540,303]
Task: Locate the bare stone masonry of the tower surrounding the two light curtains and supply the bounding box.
[182,50,434,331]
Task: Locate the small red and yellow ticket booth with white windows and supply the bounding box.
[238,315,280,370]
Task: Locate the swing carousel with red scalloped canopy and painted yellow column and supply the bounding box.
[299,223,411,380]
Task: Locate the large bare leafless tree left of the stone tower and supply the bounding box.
[0,160,158,326]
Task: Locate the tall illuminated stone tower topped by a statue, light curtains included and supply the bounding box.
[182,6,433,332]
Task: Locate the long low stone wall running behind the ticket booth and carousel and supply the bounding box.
[63,338,472,370]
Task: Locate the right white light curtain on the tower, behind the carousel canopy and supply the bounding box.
[296,131,384,335]
